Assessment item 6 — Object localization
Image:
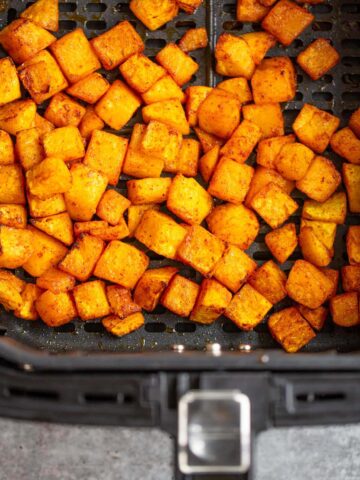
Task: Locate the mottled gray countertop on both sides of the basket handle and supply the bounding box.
[0,419,360,480]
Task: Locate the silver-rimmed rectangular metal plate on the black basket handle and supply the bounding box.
[178,390,251,474]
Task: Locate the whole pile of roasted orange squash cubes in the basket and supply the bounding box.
[0,0,360,352]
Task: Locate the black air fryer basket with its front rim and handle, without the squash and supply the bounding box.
[0,0,360,480]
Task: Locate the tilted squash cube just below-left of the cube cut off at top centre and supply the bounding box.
[91,20,145,70]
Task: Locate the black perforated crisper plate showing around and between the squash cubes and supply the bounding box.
[0,0,360,351]
